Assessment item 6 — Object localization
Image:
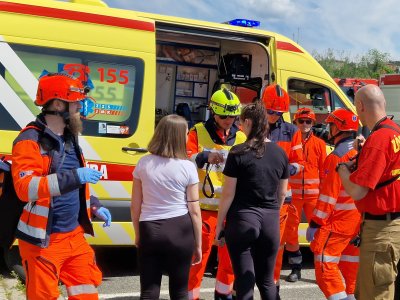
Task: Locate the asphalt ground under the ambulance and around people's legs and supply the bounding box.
[0,247,325,300]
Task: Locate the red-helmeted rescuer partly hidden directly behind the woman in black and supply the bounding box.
[261,84,304,291]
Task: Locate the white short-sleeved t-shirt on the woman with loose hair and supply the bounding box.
[133,154,199,221]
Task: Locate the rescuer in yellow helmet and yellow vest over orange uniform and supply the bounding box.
[187,88,246,299]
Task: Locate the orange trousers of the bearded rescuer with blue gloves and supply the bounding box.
[18,226,102,300]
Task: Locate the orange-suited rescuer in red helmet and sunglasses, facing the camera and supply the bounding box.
[286,107,326,282]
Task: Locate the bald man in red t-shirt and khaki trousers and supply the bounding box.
[339,85,400,300]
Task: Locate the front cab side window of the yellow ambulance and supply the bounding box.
[288,79,332,123]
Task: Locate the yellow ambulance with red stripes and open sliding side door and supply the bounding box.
[0,0,354,272]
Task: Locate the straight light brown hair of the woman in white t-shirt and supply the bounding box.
[147,115,188,159]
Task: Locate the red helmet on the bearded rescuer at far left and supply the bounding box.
[35,73,88,106]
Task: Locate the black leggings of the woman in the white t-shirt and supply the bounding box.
[138,214,194,300]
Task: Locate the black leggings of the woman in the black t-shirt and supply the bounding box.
[225,207,279,300]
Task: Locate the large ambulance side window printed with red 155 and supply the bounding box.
[0,44,144,138]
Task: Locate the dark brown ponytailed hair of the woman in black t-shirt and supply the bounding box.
[233,101,269,158]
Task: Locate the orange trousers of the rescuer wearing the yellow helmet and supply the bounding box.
[189,210,234,299]
